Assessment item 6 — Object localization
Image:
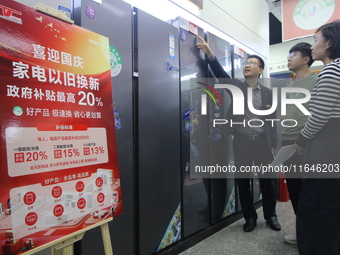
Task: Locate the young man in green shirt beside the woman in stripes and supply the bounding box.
[282,42,318,244]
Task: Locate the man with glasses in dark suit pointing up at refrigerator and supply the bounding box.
[197,36,281,232]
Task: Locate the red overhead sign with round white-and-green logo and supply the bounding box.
[282,0,340,41]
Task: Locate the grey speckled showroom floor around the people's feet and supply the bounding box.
[180,201,299,255]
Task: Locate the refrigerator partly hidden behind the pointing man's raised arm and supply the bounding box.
[206,32,236,223]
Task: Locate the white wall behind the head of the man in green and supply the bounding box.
[269,36,323,74]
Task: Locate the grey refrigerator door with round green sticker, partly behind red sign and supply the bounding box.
[73,0,135,255]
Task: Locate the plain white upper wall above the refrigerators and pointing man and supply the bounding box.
[199,0,269,57]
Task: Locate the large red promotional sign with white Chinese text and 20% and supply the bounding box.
[0,0,122,255]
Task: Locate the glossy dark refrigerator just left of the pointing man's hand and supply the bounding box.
[169,17,210,237]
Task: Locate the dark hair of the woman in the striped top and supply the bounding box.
[315,20,340,59]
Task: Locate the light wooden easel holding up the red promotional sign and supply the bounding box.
[25,217,113,255]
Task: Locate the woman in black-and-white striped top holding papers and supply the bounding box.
[295,20,340,255]
